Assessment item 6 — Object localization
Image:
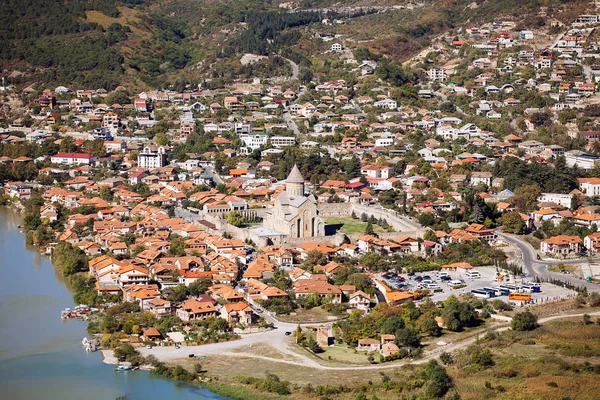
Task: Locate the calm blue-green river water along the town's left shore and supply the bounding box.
[0,207,223,400]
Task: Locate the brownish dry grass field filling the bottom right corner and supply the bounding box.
[448,317,600,399]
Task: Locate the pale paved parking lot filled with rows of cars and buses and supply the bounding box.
[384,267,576,306]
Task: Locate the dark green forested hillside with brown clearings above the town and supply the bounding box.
[0,0,584,89]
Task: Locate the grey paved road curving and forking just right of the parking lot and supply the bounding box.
[499,233,600,292]
